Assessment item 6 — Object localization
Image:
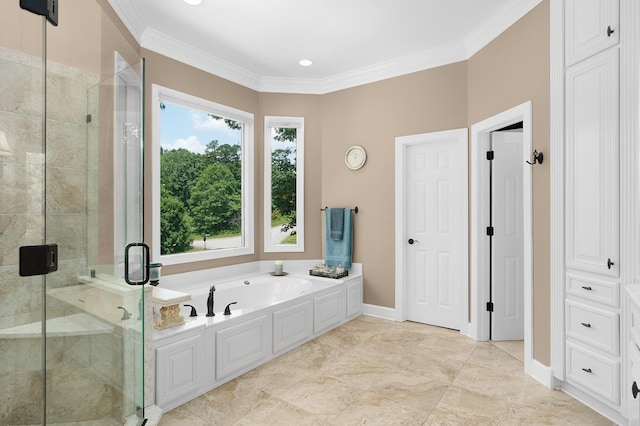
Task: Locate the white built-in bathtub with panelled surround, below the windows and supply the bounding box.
[153,273,362,410]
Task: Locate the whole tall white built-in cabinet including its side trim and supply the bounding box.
[551,0,640,424]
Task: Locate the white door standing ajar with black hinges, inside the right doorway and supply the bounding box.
[491,131,529,340]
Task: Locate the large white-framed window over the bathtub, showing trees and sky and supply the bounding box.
[152,85,254,265]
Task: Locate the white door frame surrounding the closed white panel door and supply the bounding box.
[394,128,469,334]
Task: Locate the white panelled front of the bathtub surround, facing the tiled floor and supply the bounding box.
[154,275,363,410]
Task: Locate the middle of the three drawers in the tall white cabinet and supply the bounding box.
[566,300,620,355]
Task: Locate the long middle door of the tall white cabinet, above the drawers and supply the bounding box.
[566,48,619,277]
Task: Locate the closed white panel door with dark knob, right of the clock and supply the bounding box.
[405,130,468,329]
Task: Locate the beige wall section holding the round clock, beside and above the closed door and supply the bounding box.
[320,62,467,308]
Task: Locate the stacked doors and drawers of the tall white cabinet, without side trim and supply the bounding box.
[564,0,621,410]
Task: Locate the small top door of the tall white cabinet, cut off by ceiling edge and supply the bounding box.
[565,0,620,66]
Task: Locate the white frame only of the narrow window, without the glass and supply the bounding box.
[263,115,304,253]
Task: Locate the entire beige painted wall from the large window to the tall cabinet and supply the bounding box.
[142,0,550,365]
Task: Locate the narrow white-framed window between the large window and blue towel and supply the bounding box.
[264,116,304,252]
